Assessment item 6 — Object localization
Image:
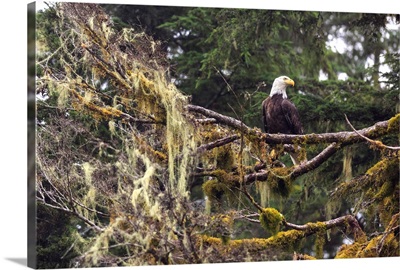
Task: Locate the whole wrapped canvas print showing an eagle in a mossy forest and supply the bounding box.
[28,2,400,269]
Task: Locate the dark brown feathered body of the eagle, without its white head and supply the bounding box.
[262,94,303,134]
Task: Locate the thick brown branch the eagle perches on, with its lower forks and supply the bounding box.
[186,105,400,188]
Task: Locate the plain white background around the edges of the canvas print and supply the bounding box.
[0,0,400,270]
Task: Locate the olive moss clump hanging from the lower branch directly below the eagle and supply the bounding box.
[267,167,293,197]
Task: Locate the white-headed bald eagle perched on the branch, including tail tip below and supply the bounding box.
[262,76,304,165]
